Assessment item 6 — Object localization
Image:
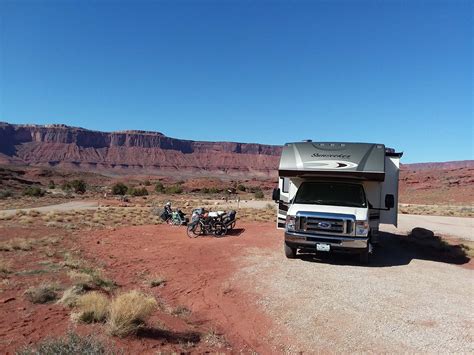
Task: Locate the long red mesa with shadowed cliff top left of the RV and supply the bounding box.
[0,123,281,177]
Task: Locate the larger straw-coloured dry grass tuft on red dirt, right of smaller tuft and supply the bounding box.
[107,291,157,337]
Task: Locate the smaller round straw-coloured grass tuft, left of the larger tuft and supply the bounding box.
[74,292,109,323]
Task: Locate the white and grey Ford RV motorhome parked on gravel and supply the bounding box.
[273,141,402,263]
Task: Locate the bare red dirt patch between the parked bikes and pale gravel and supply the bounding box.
[77,223,289,353]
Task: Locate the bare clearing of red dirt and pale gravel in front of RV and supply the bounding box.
[80,223,474,353]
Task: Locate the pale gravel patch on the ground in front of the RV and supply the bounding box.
[236,249,474,353]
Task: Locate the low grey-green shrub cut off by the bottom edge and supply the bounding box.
[17,332,117,355]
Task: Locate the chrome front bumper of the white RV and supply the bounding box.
[285,232,368,252]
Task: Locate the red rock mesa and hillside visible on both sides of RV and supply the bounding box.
[0,123,474,204]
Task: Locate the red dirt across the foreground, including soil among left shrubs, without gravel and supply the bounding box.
[0,222,472,353]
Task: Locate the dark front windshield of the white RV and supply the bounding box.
[294,182,367,207]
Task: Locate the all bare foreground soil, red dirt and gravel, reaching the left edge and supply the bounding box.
[0,216,474,353]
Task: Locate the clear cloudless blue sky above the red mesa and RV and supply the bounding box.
[0,0,474,163]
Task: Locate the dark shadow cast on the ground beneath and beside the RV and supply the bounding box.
[298,228,470,267]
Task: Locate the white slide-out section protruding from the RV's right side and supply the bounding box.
[380,156,400,227]
